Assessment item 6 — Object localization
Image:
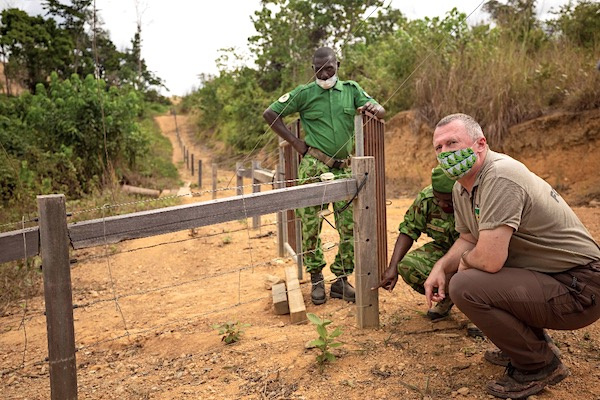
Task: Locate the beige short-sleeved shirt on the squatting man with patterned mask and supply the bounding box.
[452,150,600,273]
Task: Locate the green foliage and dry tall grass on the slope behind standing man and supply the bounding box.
[184,0,600,153]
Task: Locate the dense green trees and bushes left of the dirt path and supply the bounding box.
[0,0,177,222]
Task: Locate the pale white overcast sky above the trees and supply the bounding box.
[0,0,567,95]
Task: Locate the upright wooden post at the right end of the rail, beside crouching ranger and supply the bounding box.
[352,157,379,328]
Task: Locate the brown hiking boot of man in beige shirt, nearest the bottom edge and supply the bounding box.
[486,357,569,399]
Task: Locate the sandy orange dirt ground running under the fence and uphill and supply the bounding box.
[0,115,600,400]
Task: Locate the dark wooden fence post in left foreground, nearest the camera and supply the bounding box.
[37,194,77,400]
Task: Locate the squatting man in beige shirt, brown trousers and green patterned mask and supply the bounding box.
[425,114,600,399]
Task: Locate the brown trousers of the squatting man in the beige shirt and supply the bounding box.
[449,261,600,370]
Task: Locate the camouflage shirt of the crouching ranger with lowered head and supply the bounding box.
[398,185,459,251]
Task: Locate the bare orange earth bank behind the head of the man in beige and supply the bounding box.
[385,109,600,205]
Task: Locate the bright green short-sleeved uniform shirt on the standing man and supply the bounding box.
[269,79,377,159]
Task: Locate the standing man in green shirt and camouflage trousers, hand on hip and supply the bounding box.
[263,47,385,305]
